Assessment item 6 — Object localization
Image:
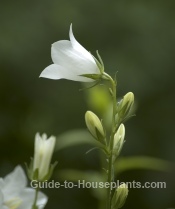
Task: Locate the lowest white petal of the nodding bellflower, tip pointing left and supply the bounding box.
[40,64,93,82]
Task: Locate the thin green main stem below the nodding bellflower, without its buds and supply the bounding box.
[103,73,117,209]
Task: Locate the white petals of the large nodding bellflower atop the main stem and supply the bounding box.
[40,25,102,82]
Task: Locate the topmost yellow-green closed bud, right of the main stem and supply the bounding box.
[118,92,134,119]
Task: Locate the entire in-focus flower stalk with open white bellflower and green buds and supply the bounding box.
[40,25,134,209]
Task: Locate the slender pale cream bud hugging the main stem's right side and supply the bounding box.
[113,124,125,161]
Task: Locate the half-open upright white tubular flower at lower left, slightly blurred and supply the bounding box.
[33,133,56,181]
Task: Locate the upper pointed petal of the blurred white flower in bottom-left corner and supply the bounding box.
[1,166,27,201]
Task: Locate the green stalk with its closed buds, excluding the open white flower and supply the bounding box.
[85,72,134,209]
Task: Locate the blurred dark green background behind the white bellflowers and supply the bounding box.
[0,0,175,209]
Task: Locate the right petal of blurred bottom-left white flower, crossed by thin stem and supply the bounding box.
[19,188,48,209]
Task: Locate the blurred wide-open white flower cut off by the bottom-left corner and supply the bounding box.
[0,166,47,209]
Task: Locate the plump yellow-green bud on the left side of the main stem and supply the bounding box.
[85,111,106,144]
